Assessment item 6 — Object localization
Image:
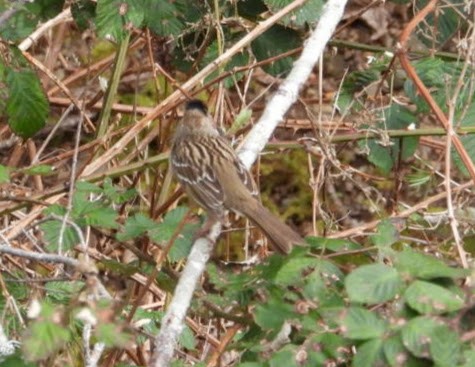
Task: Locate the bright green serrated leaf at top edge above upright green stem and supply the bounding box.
[96,0,146,42]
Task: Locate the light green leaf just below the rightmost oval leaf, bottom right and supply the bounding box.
[401,316,441,358]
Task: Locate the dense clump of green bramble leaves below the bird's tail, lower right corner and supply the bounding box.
[209,240,471,366]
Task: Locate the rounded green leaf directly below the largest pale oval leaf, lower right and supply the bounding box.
[342,307,387,340]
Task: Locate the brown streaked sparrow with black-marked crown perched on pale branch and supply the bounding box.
[170,99,304,254]
